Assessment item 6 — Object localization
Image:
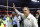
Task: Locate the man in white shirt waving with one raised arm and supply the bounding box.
[13,3,38,27]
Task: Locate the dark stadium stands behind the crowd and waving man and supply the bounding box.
[0,0,40,26]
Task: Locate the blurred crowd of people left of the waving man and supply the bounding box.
[0,12,23,27]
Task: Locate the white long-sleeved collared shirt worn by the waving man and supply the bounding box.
[15,9,38,27]
